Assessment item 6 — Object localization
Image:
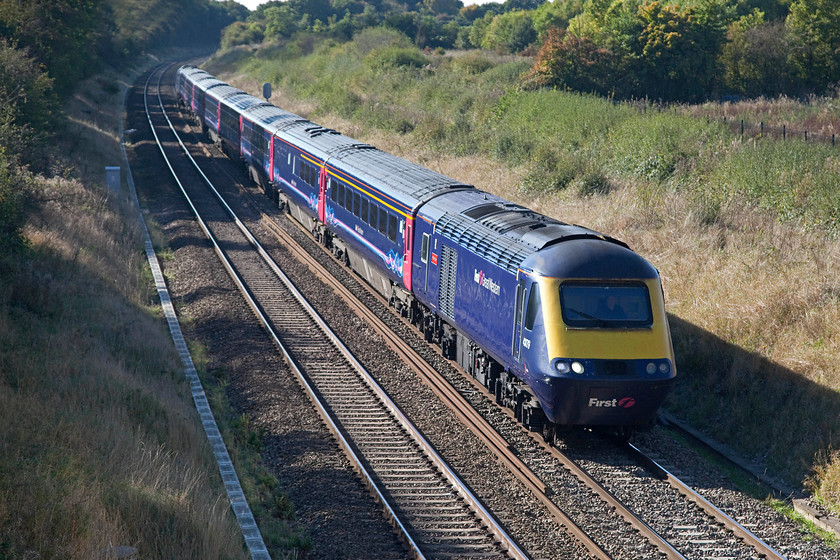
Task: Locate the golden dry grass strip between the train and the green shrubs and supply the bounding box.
[221,64,840,507]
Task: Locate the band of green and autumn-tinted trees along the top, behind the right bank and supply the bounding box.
[223,0,840,102]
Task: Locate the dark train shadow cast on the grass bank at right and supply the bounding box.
[665,315,840,488]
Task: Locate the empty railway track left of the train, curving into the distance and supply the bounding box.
[142,62,526,558]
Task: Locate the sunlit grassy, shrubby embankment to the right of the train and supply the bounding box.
[209,30,840,511]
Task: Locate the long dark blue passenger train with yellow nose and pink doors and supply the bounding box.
[175,65,676,438]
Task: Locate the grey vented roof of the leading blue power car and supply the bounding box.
[418,190,640,276]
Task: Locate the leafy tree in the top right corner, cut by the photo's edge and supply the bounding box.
[787,0,840,89]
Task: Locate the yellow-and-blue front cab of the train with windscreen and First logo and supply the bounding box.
[514,238,676,426]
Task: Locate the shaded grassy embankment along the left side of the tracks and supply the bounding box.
[0,62,306,559]
